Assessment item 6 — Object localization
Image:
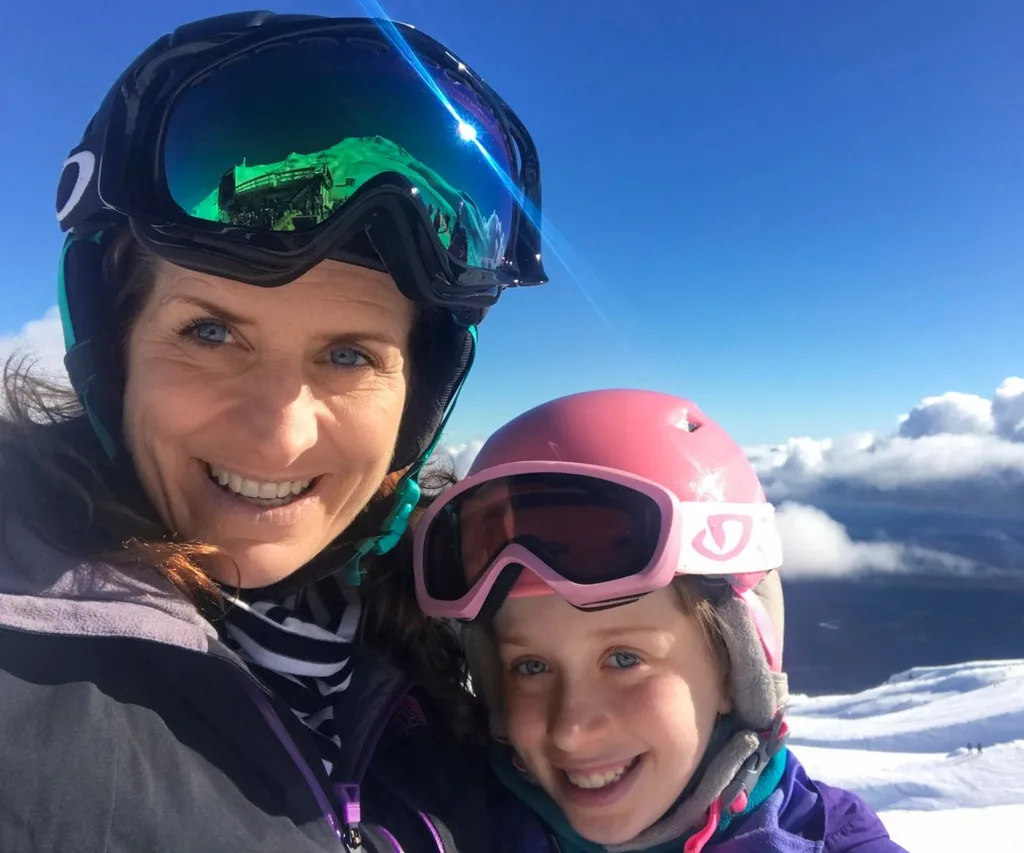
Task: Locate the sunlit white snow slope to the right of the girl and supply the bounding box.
[788,660,1024,853]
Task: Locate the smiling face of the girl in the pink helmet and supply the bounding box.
[496,587,729,845]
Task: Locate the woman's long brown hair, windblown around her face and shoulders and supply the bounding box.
[0,228,475,730]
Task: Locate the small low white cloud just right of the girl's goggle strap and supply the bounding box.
[776,503,976,579]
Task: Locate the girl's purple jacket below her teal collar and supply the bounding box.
[703,752,906,853]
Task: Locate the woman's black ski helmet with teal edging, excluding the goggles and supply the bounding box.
[56,11,543,471]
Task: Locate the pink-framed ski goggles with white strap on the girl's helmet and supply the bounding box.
[414,462,782,621]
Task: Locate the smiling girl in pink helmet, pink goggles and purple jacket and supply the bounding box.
[415,391,900,853]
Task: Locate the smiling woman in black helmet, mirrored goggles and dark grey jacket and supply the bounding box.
[0,13,545,853]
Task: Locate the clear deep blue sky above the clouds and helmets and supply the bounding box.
[0,0,1024,443]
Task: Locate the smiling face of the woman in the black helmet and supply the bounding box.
[124,261,414,588]
